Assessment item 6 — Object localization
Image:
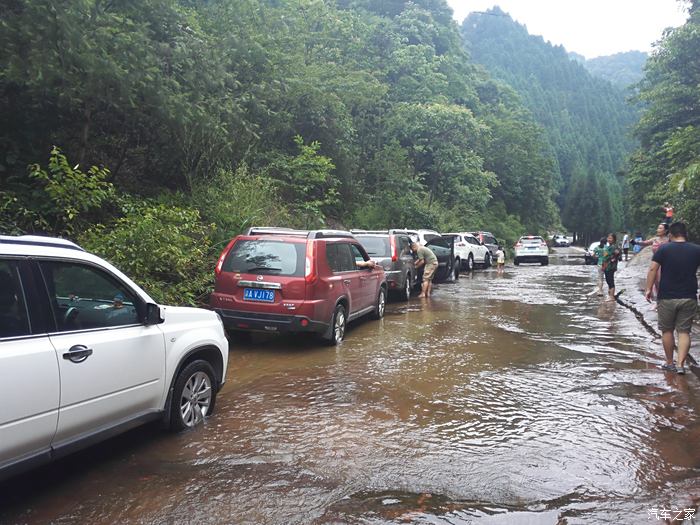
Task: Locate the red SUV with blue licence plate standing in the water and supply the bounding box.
[210,228,387,344]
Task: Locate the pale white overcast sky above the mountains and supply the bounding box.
[447,0,686,58]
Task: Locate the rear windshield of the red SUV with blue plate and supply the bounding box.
[221,239,306,277]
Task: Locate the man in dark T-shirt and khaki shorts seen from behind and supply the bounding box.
[644,222,700,374]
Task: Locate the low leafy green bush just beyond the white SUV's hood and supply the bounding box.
[79,201,216,305]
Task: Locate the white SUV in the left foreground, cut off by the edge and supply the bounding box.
[0,236,228,479]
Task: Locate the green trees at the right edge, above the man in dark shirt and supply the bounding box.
[626,0,700,231]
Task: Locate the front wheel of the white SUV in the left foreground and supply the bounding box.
[170,359,216,430]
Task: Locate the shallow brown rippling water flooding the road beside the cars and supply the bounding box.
[0,260,700,524]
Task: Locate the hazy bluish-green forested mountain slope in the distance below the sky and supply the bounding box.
[461,8,637,241]
